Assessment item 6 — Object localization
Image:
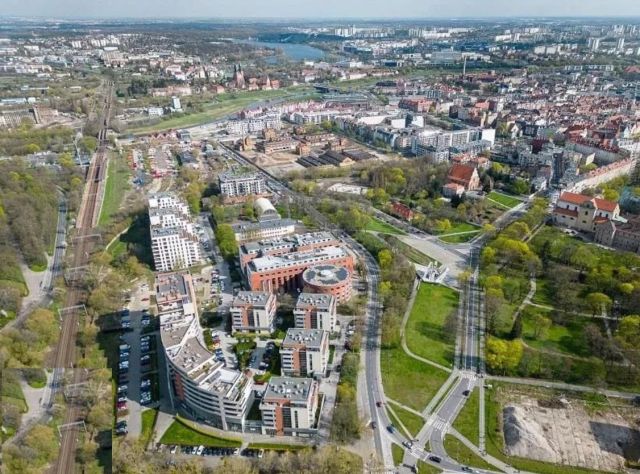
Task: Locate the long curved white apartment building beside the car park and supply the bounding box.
[155,273,253,431]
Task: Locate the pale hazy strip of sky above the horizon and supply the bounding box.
[0,0,640,19]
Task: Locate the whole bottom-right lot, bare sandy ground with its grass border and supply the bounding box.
[486,382,640,474]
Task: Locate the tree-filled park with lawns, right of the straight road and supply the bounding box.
[481,201,640,387]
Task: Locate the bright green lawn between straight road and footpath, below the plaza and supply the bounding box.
[405,283,459,367]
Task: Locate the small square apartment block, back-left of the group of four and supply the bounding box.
[230,291,276,333]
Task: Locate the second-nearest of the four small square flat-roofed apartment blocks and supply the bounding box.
[280,328,329,377]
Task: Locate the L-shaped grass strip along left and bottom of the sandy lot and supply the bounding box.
[484,381,616,474]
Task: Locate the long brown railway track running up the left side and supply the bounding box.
[50,82,114,474]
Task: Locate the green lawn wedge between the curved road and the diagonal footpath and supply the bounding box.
[380,347,449,411]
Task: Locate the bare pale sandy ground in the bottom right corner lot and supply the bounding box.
[503,396,640,471]
